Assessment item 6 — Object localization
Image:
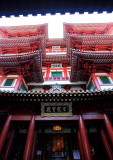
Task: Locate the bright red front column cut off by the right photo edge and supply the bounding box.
[104,114,113,145]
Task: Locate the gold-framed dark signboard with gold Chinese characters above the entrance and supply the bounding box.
[41,102,72,117]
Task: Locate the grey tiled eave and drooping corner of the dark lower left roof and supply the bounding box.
[0,51,44,82]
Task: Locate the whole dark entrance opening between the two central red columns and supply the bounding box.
[36,125,77,160]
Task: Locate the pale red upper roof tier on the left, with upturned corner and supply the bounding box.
[0,35,45,54]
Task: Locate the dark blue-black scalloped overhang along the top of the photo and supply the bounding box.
[0,0,113,16]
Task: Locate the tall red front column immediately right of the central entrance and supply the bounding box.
[79,116,92,160]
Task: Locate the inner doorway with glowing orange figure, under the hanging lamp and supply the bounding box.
[46,134,70,160]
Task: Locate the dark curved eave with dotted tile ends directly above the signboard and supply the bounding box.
[0,89,113,102]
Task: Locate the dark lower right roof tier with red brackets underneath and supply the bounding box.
[71,50,113,82]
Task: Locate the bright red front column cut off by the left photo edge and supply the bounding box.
[0,115,12,154]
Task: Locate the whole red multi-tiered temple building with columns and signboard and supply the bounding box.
[0,12,113,160]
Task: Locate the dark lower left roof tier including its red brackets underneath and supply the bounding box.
[0,51,43,82]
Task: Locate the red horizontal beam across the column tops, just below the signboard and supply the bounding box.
[11,114,104,121]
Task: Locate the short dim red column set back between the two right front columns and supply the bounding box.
[100,130,113,160]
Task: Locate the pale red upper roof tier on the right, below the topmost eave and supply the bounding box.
[68,34,113,51]
